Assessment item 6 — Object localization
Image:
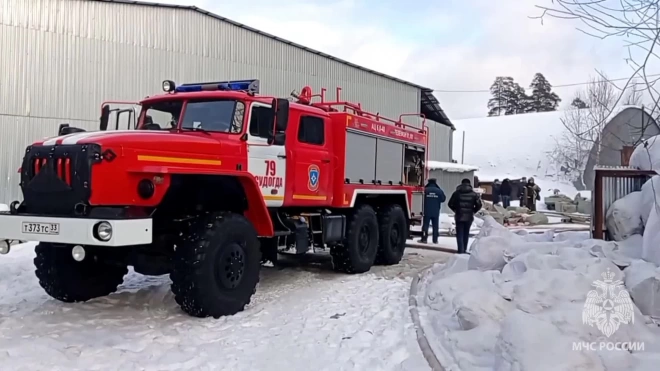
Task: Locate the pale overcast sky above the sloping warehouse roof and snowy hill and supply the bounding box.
[152,0,648,120]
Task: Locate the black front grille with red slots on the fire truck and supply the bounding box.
[21,144,101,215]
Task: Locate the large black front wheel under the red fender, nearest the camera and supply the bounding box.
[170,212,261,318]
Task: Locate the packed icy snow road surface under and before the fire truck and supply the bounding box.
[0,244,448,371]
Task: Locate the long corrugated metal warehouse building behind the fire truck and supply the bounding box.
[0,0,453,203]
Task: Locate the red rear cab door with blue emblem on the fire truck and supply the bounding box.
[289,113,334,205]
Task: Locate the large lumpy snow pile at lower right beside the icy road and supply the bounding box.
[418,217,660,371]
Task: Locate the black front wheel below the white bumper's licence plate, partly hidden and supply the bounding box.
[34,242,128,303]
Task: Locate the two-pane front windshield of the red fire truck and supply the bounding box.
[139,100,245,134]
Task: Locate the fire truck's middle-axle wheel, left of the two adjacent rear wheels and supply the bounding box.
[330,205,378,273]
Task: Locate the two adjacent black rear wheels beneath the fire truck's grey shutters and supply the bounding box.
[330,205,408,273]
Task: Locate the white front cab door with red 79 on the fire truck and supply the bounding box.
[247,102,286,207]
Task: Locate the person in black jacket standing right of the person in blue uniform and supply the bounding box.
[447,179,482,254]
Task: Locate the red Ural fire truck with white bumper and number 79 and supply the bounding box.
[0,80,427,318]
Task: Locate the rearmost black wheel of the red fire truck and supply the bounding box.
[376,205,408,265]
